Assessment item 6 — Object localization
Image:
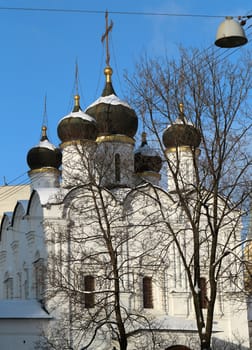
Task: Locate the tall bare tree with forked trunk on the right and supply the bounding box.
[126,49,252,349]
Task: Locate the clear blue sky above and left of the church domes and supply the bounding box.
[0,0,252,185]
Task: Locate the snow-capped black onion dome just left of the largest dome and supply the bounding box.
[57,95,97,142]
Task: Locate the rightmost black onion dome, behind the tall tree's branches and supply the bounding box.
[163,104,201,148]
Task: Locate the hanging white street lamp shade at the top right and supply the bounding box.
[215,17,248,48]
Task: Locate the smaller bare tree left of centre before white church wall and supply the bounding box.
[40,145,175,350]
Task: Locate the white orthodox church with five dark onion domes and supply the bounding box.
[0,15,249,350]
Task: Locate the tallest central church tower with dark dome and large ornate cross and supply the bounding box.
[86,14,138,188]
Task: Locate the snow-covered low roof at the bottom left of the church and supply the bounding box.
[0,299,52,319]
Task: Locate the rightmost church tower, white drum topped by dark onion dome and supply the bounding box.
[163,103,201,191]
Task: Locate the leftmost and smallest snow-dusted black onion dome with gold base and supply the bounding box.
[27,126,62,170]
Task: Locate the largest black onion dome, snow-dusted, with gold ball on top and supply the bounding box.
[86,67,138,138]
